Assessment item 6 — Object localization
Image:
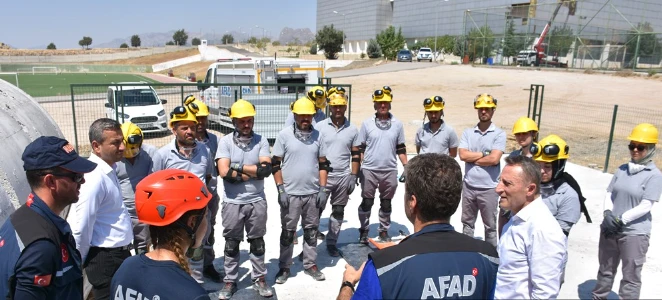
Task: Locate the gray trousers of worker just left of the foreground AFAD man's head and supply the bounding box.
[359,170,398,232]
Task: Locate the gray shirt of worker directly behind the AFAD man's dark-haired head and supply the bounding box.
[415,122,459,155]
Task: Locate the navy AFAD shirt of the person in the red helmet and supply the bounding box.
[110,254,210,300]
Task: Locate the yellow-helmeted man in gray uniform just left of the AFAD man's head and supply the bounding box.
[359,86,407,245]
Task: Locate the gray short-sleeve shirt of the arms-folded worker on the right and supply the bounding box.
[458,124,506,189]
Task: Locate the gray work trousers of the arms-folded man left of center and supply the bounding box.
[221,200,267,283]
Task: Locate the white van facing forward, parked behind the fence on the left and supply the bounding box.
[104,82,169,133]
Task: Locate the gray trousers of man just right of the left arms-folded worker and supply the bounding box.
[278,193,320,269]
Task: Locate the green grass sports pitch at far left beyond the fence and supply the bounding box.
[0,73,156,97]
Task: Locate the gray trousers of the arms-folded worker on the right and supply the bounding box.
[462,182,499,247]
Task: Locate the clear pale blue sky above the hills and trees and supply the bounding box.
[0,0,317,49]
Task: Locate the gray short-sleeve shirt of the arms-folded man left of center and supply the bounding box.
[215,134,269,204]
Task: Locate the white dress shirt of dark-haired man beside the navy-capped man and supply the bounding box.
[68,153,133,261]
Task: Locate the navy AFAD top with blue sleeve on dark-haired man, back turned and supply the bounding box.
[352,224,499,299]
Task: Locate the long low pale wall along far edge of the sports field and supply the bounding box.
[0,46,195,64]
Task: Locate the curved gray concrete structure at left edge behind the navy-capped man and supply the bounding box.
[0,80,63,224]
